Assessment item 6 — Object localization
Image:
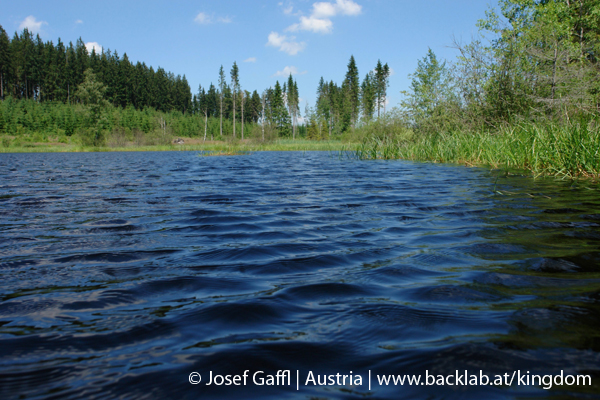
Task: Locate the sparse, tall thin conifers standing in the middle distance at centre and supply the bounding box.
[193,56,390,139]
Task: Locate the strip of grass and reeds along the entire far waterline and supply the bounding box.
[0,123,600,180]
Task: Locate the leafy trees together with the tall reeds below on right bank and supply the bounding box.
[346,0,600,178]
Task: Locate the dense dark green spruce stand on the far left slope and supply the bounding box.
[0,26,192,113]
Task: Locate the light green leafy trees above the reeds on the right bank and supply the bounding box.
[400,0,600,133]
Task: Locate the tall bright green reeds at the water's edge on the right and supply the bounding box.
[355,121,600,178]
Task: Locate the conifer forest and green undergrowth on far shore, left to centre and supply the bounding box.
[0,20,389,147]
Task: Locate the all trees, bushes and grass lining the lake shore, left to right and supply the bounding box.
[0,0,600,175]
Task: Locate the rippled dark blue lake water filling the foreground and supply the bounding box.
[0,152,600,399]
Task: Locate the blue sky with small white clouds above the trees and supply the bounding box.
[0,0,496,110]
